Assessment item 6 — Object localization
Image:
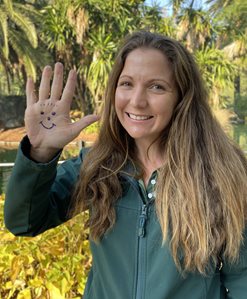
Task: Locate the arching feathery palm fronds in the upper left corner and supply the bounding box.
[0,0,40,91]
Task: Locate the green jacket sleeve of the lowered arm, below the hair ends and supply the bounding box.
[221,228,247,299]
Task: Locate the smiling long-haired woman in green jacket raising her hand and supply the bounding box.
[5,32,247,299]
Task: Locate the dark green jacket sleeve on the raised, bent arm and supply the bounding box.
[4,137,82,236]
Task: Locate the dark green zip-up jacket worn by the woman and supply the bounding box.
[5,138,247,299]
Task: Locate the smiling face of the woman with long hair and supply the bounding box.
[115,48,178,148]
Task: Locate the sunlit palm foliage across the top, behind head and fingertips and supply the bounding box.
[0,0,247,114]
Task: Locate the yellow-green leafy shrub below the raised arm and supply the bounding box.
[0,196,91,299]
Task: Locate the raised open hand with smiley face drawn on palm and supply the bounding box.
[25,63,99,162]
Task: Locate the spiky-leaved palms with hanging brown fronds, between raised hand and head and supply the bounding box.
[41,0,160,113]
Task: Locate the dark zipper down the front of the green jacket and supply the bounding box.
[136,204,148,299]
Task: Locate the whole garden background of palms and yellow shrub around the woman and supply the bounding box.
[0,0,247,299]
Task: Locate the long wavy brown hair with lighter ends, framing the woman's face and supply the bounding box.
[70,31,247,273]
